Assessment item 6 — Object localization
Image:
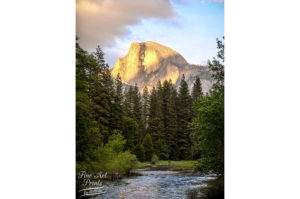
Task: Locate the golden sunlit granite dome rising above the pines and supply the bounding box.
[111,41,212,92]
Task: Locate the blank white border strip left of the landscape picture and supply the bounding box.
[0,0,75,199]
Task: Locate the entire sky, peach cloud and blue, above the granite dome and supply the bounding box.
[76,0,224,67]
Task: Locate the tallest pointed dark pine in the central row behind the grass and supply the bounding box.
[177,75,192,159]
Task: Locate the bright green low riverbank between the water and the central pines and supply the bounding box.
[138,160,197,171]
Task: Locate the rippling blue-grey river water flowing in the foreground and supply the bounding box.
[86,169,215,199]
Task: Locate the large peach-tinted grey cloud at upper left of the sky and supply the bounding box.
[76,0,175,50]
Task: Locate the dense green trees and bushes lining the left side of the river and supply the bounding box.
[76,41,137,175]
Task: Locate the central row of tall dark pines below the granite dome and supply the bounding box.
[117,75,203,161]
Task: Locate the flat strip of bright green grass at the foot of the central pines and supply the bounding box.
[138,160,197,170]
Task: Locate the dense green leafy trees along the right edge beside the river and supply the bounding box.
[190,37,224,174]
